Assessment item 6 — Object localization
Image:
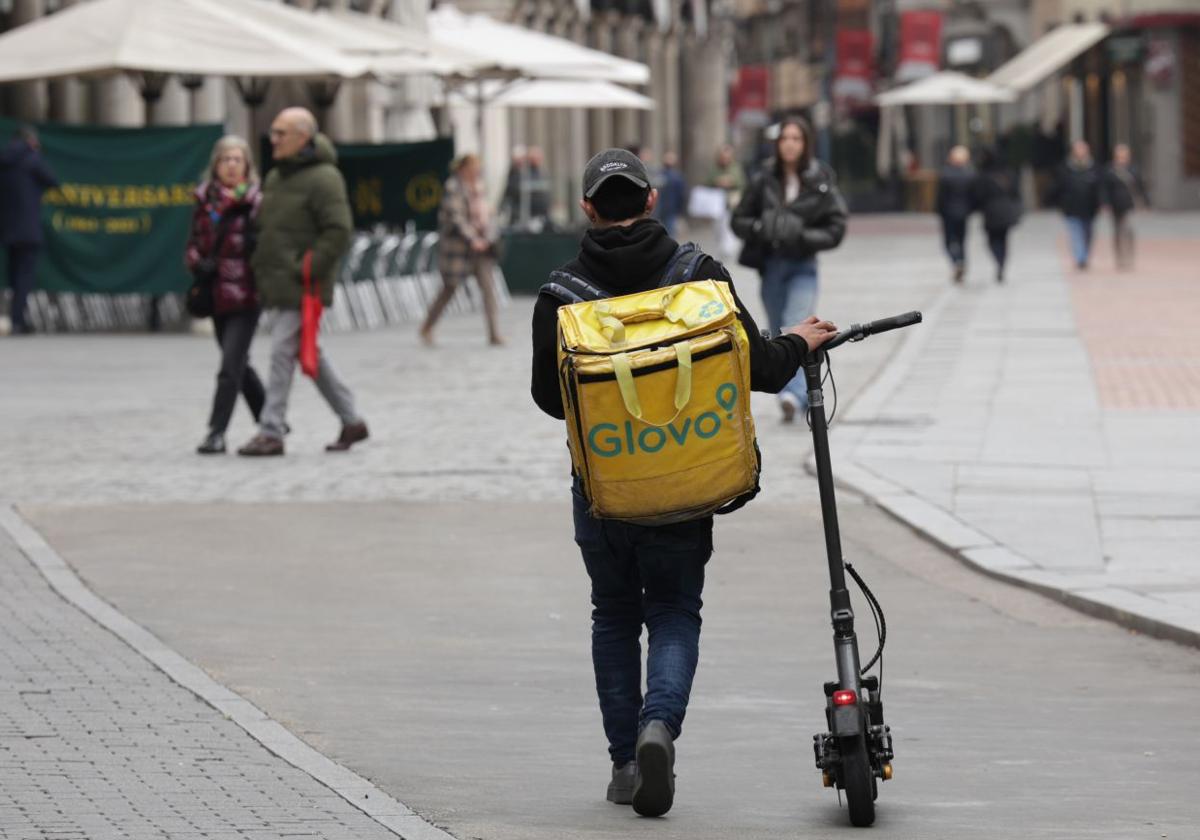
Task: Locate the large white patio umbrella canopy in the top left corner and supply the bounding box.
[0,0,368,82]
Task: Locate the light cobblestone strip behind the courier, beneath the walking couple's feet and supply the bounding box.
[0,218,943,504]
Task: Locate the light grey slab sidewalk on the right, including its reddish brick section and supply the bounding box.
[834,215,1200,644]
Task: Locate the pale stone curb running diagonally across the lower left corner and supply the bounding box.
[0,506,455,840]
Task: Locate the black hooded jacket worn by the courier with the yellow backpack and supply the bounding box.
[530,218,808,420]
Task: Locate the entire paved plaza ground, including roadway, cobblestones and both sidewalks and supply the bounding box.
[0,216,1200,840]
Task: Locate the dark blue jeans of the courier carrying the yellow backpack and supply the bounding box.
[572,490,713,764]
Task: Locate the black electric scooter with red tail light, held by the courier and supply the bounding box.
[804,312,920,827]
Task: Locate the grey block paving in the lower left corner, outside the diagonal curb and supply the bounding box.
[0,520,395,840]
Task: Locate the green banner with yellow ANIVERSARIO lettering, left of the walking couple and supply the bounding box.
[0,120,222,294]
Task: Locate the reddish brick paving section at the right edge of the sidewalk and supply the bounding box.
[1062,236,1200,410]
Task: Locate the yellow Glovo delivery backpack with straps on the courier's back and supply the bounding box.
[542,244,758,524]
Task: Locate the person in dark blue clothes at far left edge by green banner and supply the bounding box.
[0,126,59,336]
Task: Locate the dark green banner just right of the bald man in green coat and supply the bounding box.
[263,138,454,230]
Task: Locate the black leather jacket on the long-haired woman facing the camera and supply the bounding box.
[733,160,848,258]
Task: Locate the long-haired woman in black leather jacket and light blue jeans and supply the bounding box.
[733,116,848,422]
